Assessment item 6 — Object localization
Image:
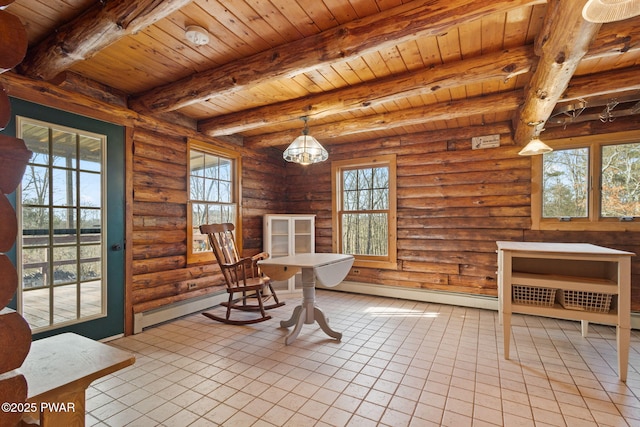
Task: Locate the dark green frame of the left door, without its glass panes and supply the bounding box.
[0,98,125,340]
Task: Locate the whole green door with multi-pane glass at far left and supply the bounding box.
[3,99,125,339]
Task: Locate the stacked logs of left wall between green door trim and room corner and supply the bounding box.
[130,128,284,313]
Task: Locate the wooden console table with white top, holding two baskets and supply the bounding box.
[496,242,635,381]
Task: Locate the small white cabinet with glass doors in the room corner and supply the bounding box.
[262,214,316,292]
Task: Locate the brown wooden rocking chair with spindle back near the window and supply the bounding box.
[200,223,284,325]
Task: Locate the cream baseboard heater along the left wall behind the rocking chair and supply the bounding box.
[133,290,228,334]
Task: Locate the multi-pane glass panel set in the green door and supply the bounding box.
[17,117,106,332]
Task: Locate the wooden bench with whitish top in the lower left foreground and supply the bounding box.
[19,333,135,427]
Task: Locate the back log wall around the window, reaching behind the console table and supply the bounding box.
[287,124,640,311]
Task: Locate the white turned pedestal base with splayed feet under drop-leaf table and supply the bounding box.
[280,268,342,345]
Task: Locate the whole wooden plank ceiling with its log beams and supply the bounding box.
[6,0,640,148]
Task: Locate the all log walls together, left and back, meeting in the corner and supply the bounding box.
[0,73,640,333]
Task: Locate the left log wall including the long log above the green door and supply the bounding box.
[0,73,287,334]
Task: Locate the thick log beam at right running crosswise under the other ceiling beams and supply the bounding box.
[514,0,602,145]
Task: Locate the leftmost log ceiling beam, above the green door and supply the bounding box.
[18,0,193,80]
